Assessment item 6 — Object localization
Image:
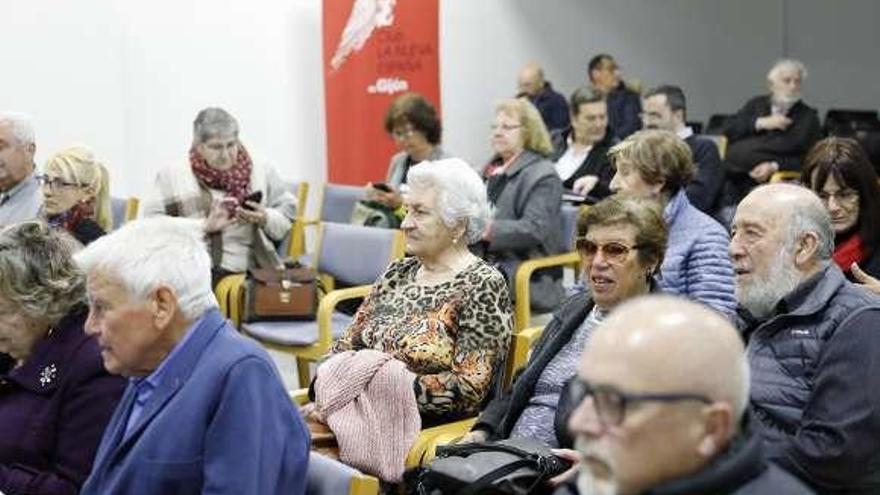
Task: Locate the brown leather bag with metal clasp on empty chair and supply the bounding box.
[242,264,318,323]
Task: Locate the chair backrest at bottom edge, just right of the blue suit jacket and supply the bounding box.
[306,451,379,495]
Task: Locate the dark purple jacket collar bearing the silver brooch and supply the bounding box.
[6,306,88,395]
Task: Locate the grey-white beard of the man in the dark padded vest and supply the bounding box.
[736,246,801,318]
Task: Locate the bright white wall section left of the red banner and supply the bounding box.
[0,0,325,196]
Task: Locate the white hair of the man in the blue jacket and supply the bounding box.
[74,216,217,320]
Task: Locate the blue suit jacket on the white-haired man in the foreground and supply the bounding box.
[81,309,310,495]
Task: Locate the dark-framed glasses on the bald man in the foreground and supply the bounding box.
[568,376,712,427]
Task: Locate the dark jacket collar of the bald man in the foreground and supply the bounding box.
[645,415,767,495]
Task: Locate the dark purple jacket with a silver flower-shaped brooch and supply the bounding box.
[0,307,125,495]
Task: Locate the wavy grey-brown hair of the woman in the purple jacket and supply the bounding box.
[0,221,86,324]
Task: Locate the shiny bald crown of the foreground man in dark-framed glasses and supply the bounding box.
[581,296,748,420]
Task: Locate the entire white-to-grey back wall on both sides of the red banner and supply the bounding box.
[0,0,880,196]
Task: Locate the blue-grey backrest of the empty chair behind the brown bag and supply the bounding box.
[315,222,405,285]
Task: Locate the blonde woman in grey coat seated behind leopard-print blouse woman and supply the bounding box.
[482,98,563,312]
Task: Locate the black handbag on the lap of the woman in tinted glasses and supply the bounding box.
[417,438,571,495]
